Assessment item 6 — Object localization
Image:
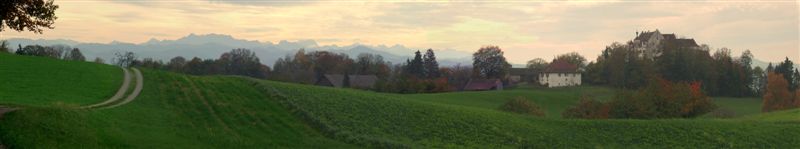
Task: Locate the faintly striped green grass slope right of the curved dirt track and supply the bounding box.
[0,70,348,148]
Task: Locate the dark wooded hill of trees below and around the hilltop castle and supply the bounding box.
[583,42,795,97]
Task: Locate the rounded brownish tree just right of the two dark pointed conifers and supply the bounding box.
[472,45,511,79]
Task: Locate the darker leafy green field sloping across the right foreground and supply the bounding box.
[259,81,800,148]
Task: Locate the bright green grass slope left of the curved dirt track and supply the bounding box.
[0,53,123,107]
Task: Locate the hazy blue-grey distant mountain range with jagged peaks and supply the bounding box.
[7,34,472,66]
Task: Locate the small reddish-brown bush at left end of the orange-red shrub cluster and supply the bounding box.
[561,97,611,119]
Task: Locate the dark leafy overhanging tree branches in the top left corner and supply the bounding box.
[0,0,58,34]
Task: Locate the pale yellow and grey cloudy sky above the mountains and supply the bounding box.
[0,0,800,63]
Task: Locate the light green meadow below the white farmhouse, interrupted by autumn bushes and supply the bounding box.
[402,86,761,118]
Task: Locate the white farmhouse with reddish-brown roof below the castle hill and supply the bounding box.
[539,61,581,87]
